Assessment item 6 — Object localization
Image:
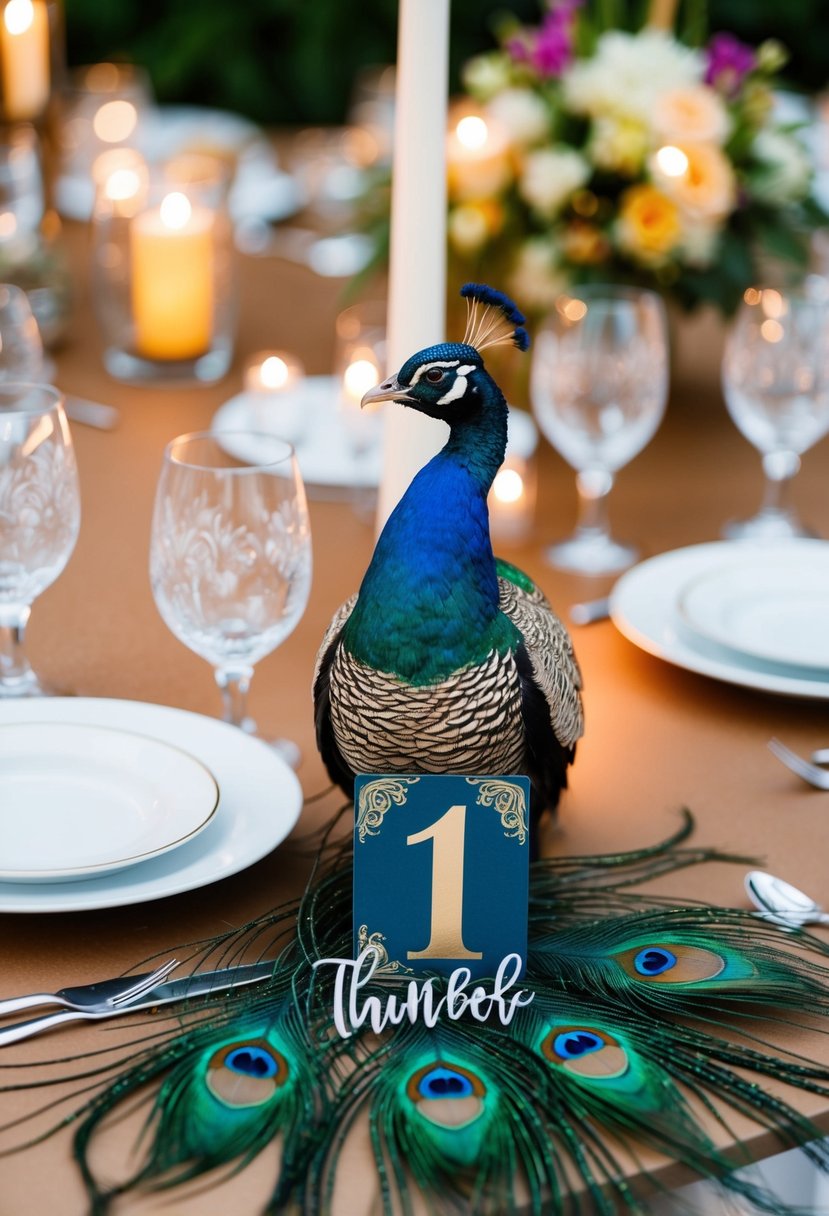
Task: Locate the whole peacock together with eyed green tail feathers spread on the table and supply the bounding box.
[8,286,829,1216]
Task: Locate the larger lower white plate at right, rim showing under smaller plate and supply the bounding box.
[610,540,829,700]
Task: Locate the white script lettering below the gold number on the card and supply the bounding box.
[314,946,535,1038]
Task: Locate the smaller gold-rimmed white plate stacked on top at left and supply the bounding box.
[0,720,219,883]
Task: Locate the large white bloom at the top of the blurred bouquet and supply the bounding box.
[563,29,704,125]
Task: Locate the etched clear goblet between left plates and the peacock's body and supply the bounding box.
[150,432,311,764]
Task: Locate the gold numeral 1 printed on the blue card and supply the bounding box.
[406,805,484,958]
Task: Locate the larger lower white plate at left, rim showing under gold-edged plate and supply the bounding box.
[0,697,303,912]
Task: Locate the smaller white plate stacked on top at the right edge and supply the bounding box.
[677,556,829,680]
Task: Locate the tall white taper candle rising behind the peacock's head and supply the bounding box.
[377,0,449,530]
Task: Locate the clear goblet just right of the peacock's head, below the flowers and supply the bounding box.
[530,285,669,575]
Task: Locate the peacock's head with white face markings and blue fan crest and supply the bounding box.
[362,283,530,426]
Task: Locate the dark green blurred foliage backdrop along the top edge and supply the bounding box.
[66,0,829,124]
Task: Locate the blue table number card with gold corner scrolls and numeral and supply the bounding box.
[354,773,530,978]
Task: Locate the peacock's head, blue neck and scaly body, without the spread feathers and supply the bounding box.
[314,283,583,840]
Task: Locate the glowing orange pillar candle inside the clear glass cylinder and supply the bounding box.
[130,191,214,360]
